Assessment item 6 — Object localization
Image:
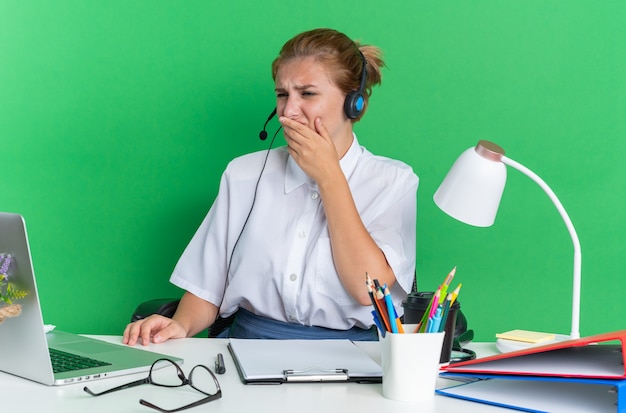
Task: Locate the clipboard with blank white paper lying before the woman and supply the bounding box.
[228,338,383,384]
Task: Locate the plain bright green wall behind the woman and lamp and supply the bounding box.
[0,0,626,341]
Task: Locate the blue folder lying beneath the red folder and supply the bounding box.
[436,374,626,413]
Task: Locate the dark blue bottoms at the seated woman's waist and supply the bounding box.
[218,308,378,341]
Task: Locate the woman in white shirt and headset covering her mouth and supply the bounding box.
[124,29,418,345]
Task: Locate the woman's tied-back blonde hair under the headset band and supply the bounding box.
[272,28,384,121]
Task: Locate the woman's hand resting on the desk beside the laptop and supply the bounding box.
[122,314,187,346]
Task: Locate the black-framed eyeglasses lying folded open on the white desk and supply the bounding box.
[83,359,222,413]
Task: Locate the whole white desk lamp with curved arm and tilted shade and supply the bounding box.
[434,140,582,351]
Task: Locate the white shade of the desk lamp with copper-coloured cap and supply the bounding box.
[434,141,506,227]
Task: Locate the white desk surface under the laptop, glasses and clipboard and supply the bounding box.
[0,336,510,413]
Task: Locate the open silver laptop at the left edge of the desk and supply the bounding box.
[0,212,183,385]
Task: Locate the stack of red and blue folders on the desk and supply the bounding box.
[436,330,626,413]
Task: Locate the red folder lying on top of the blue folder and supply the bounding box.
[442,330,626,380]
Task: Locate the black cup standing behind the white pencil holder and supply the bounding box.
[402,292,461,364]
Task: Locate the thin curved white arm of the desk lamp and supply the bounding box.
[501,155,582,339]
